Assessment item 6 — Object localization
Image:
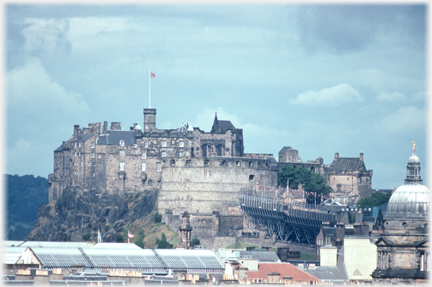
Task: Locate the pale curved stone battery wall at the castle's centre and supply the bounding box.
[158,157,277,214]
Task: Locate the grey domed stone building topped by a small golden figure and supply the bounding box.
[372,142,430,283]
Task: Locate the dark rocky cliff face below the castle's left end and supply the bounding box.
[25,187,157,242]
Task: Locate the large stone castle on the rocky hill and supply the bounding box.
[48,109,372,214]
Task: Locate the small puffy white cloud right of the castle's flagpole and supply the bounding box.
[290,83,363,106]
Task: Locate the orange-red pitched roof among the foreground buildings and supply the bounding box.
[248,262,321,282]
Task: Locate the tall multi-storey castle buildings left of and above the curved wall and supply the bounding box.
[48,109,244,201]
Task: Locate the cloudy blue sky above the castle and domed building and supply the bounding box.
[4,3,428,189]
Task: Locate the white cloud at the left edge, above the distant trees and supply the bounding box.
[7,58,90,112]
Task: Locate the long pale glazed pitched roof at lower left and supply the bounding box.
[3,245,224,270]
